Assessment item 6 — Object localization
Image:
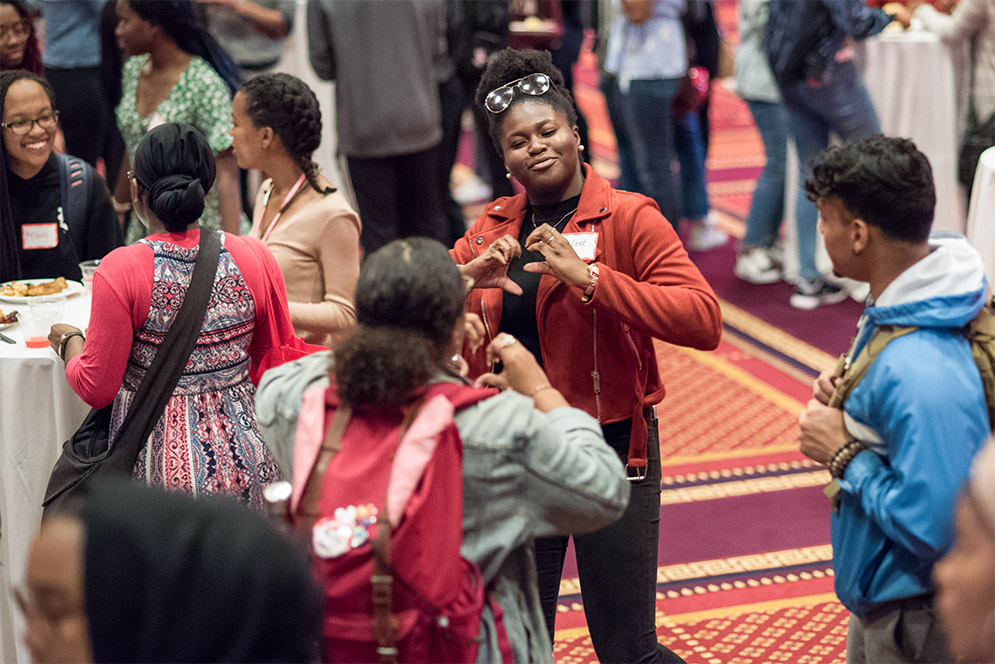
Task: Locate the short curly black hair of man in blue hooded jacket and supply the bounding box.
[804,136,936,242]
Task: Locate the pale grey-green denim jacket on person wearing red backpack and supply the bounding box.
[256,353,629,662]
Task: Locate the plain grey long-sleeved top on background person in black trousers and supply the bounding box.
[307,0,446,158]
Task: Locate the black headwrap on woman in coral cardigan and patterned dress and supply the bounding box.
[135,122,215,232]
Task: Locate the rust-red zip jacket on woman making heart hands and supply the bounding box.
[450,165,722,465]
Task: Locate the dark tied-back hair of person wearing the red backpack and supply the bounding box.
[334,237,466,408]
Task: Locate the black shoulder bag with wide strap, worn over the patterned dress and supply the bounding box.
[42,230,221,515]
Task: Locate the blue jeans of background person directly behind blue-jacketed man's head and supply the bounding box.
[781,62,881,281]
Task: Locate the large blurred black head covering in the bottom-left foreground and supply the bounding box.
[83,481,321,662]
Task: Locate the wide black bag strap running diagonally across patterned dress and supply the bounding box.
[108,229,221,470]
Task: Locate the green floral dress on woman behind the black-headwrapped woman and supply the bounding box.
[116,53,232,244]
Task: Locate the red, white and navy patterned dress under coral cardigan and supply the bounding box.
[111,234,281,509]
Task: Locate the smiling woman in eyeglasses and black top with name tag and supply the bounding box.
[0,69,121,282]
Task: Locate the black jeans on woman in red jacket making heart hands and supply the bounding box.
[535,409,684,662]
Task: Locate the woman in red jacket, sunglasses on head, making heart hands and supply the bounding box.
[451,49,721,662]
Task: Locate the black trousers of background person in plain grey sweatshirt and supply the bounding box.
[348,145,447,256]
